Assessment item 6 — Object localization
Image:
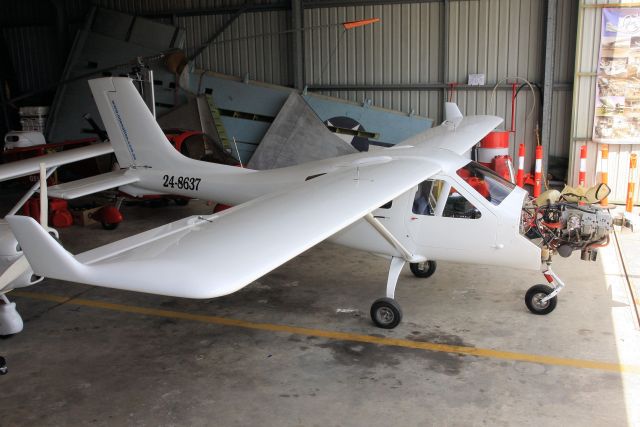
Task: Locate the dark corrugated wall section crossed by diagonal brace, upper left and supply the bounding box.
[78,0,292,85]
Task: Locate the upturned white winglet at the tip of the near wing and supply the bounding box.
[5,215,86,282]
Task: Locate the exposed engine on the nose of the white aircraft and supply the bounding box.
[522,201,613,261]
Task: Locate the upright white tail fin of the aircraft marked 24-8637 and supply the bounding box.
[89,77,186,169]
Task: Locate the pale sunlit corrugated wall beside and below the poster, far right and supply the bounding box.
[570,0,640,204]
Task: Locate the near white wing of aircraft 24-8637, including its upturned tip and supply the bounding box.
[6,156,440,298]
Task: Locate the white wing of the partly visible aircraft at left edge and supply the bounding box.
[0,142,113,181]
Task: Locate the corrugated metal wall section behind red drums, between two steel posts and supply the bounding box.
[447,0,544,167]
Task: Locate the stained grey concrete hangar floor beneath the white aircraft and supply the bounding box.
[0,202,640,426]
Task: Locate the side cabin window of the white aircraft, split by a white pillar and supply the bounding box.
[412,179,481,219]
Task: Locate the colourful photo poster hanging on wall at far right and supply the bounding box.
[593,7,640,144]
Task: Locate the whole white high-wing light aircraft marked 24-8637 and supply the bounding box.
[0,78,610,338]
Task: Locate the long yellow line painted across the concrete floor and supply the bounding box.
[11,291,640,374]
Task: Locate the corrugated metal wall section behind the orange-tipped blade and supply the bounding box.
[304,3,443,117]
